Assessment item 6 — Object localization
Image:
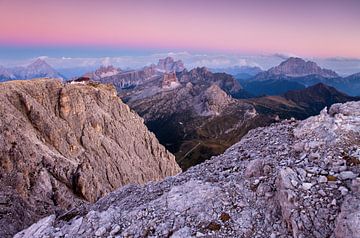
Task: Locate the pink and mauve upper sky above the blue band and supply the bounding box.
[0,0,360,57]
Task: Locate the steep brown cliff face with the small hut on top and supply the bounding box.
[0,79,180,237]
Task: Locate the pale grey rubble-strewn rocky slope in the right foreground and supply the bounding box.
[16,102,360,238]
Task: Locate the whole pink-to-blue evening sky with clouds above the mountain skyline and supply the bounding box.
[0,0,360,75]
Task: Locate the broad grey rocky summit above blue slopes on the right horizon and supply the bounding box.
[268,57,339,78]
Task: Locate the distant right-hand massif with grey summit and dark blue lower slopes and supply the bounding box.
[240,58,360,96]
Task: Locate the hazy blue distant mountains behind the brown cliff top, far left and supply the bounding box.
[0,59,65,82]
